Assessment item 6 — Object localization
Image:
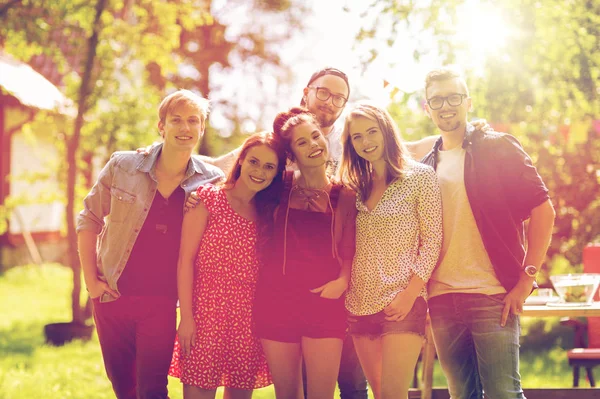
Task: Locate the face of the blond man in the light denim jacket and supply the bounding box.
[158,103,204,151]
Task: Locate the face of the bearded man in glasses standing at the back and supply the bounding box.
[304,75,348,128]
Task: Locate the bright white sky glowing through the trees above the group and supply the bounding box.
[211,0,510,131]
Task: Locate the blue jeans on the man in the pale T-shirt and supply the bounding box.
[429,294,525,399]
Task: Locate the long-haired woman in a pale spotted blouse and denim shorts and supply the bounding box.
[340,103,442,399]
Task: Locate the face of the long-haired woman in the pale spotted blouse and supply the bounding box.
[348,116,385,163]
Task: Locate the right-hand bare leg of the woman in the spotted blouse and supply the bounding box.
[381,333,423,399]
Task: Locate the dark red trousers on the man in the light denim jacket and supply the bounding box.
[94,296,176,399]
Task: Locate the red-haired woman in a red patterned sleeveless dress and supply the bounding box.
[170,133,286,399]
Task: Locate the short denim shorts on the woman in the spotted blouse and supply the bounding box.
[348,297,427,339]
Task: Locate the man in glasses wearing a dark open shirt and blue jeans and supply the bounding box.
[422,68,554,399]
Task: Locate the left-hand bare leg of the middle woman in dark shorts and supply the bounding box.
[260,339,304,399]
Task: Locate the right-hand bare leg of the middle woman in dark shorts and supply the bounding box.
[302,337,343,399]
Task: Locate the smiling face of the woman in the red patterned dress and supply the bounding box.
[238,144,279,192]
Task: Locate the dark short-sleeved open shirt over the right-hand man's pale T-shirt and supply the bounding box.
[421,125,549,292]
